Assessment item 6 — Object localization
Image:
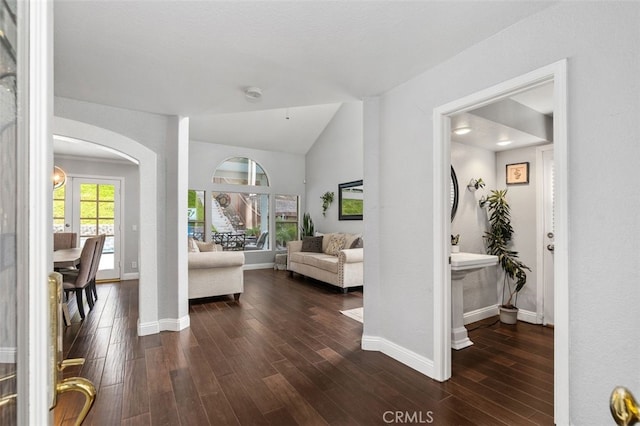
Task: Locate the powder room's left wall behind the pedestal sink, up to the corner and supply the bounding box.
[451,142,498,313]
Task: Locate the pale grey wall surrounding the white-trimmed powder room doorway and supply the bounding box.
[364,2,640,425]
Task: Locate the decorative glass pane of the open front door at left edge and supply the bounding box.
[0,2,18,425]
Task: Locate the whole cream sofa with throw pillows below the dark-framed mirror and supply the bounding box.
[287,233,364,293]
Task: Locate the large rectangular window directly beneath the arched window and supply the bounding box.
[211,192,269,250]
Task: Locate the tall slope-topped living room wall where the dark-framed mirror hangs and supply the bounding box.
[304,102,360,234]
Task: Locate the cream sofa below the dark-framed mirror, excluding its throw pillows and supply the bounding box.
[287,234,364,293]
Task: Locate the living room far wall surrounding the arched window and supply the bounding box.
[189,141,305,264]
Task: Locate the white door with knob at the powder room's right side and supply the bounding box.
[542,149,555,325]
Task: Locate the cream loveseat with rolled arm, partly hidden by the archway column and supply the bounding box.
[188,239,244,301]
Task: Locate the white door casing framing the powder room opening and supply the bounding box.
[430,59,570,424]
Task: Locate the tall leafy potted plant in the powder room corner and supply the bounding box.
[480,189,531,324]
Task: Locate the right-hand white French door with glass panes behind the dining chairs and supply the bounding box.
[71,177,121,280]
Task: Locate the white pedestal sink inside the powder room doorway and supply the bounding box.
[451,253,498,350]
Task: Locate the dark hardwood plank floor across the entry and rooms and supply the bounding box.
[55,270,553,426]
